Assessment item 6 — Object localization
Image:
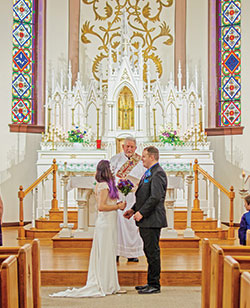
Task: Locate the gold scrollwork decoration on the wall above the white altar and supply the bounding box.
[81,0,173,82]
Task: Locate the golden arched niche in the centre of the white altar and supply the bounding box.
[118,87,134,130]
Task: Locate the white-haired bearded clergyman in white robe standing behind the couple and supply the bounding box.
[110,137,146,262]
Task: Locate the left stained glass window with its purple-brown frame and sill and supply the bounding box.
[10,0,46,133]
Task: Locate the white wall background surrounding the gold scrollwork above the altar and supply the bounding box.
[79,0,175,84]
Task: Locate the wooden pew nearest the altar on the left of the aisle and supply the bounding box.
[0,239,41,308]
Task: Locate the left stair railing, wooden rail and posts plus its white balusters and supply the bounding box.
[18,159,58,239]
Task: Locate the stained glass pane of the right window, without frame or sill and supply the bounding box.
[218,0,241,127]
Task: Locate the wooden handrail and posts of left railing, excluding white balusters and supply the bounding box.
[18,159,58,239]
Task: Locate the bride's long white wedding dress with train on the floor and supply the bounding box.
[50,182,120,297]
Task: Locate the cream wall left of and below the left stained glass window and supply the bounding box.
[0,1,40,222]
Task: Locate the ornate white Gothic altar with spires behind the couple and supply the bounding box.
[36,12,215,238]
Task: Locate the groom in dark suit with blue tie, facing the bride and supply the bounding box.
[124,146,167,294]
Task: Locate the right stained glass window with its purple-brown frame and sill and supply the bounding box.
[206,0,243,136]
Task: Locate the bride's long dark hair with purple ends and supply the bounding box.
[95,160,119,199]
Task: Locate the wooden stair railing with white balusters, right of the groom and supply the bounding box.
[193,159,235,238]
